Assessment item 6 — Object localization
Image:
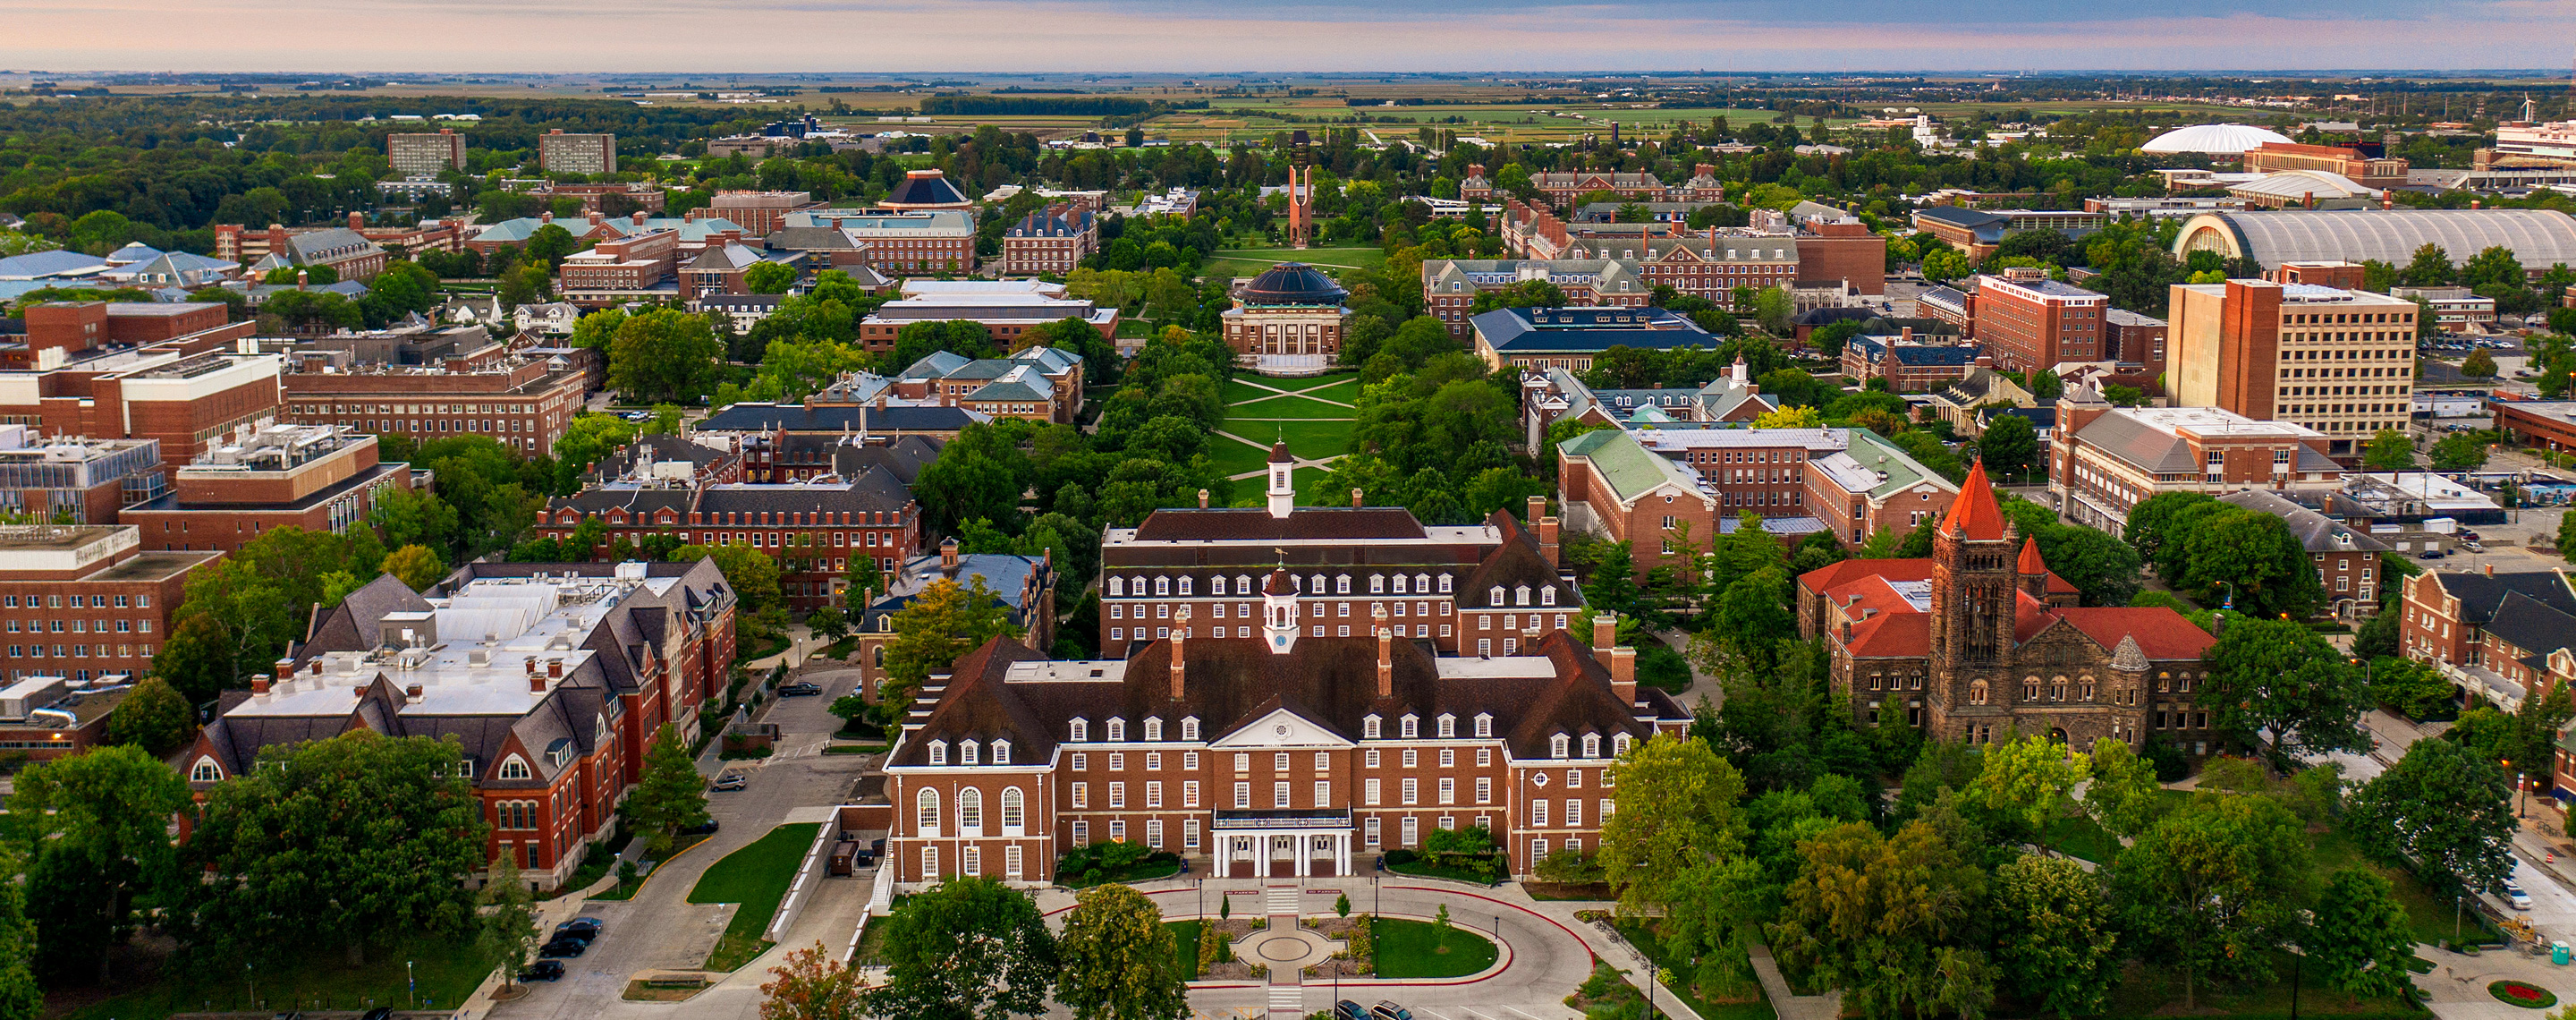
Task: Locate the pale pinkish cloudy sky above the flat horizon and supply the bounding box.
[14,0,2576,72]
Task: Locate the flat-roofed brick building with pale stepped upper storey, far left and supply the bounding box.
[118,425,412,554]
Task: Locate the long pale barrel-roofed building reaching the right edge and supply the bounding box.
[2174,208,2576,273]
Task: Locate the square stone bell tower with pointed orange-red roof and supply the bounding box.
[1929,461,2022,677]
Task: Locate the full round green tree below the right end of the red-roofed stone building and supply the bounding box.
[2110,794,2308,1012]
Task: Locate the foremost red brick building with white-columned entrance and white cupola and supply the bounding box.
[884,610,1690,888]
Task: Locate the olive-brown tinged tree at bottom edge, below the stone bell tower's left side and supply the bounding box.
[1770,821,1996,1020]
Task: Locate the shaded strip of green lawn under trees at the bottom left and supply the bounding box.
[64,938,492,1020]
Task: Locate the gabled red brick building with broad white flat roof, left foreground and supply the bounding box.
[181,559,737,888]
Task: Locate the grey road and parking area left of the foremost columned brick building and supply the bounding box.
[492,672,869,1020]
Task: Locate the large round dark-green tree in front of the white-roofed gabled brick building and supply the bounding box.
[175,729,487,964]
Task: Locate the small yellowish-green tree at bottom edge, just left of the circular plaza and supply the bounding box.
[1056,883,1191,1020]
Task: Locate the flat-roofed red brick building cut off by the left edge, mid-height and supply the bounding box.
[0,525,219,683]
